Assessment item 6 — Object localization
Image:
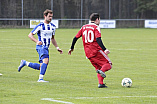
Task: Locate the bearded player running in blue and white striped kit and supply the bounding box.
[18,9,63,82]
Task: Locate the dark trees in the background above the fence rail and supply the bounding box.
[0,0,157,19]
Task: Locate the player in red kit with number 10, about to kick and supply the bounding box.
[68,13,112,88]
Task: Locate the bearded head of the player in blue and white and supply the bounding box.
[43,9,53,23]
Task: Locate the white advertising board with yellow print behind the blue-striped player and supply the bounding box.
[30,20,59,28]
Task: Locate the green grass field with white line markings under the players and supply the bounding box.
[0,29,157,104]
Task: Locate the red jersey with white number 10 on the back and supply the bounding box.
[75,23,102,58]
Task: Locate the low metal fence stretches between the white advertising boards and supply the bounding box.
[0,18,145,28]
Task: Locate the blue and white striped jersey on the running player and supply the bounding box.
[32,22,56,48]
